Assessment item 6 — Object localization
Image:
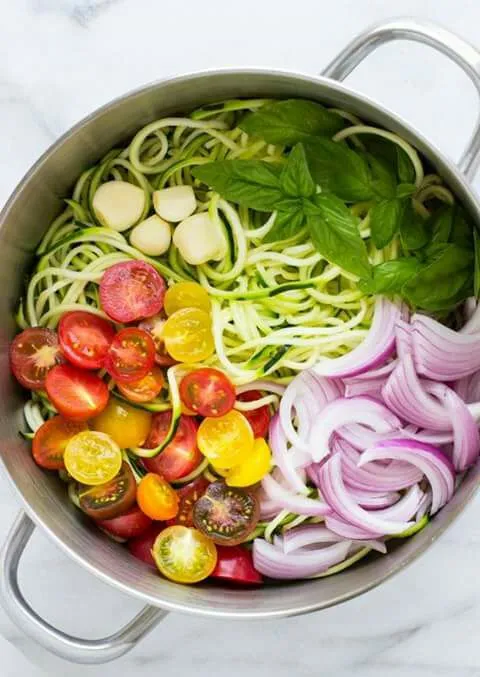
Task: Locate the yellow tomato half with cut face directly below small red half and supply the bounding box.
[197,409,254,469]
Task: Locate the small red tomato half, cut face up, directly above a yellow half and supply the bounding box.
[180,367,235,417]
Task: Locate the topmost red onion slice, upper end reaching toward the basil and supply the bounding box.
[314,297,404,378]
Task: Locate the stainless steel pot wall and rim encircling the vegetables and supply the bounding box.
[0,71,480,618]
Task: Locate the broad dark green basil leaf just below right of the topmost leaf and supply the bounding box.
[305,138,375,202]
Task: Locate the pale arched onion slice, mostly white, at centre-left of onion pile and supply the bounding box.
[310,397,401,462]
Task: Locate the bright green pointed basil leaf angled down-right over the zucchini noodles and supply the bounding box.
[306,193,371,277]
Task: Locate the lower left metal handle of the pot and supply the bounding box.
[0,512,167,664]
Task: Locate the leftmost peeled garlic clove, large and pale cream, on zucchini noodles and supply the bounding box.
[92,181,145,232]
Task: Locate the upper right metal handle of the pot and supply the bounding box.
[322,17,480,179]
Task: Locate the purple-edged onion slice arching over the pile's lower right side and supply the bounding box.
[362,439,455,514]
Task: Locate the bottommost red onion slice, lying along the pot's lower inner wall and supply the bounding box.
[253,538,351,579]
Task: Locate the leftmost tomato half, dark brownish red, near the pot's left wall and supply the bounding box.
[10,327,62,390]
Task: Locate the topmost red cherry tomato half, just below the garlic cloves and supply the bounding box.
[100,261,166,323]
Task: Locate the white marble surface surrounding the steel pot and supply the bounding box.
[0,0,480,677]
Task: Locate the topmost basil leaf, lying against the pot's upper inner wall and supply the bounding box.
[239,99,345,146]
